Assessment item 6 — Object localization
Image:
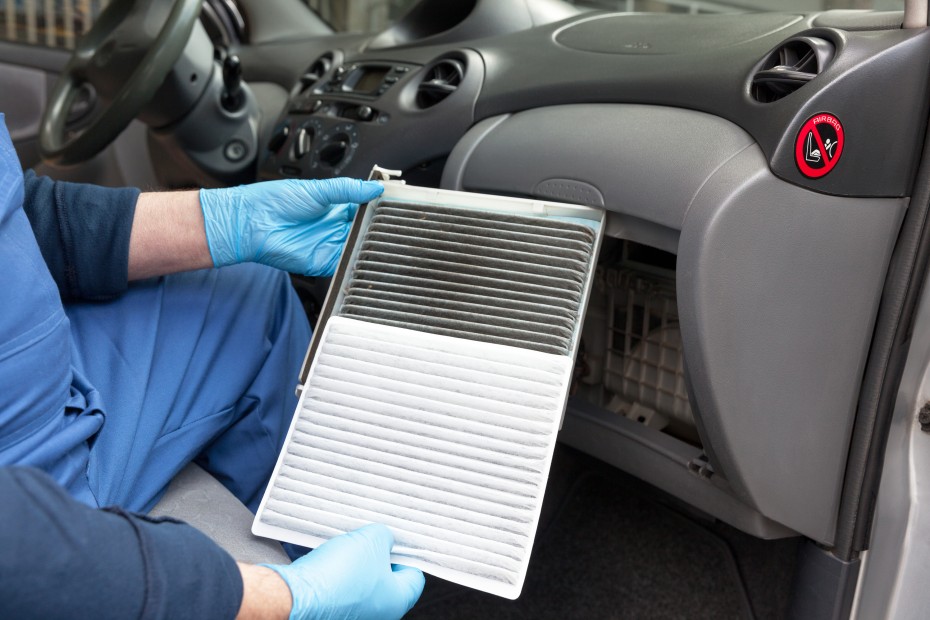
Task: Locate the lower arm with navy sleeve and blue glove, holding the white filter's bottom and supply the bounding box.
[0,467,424,620]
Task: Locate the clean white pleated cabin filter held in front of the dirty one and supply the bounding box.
[253,317,574,598]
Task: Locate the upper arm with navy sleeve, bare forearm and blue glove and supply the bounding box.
[23,171,383,300]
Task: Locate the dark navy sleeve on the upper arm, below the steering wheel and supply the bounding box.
[23,170,140,300]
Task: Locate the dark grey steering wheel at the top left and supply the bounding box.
[39,0,202,165]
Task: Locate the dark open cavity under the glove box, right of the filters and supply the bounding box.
[559,238,797,539]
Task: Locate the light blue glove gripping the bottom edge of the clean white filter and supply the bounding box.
[262,524,426,620]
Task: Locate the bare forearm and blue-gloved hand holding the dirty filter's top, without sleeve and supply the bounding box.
[129,179,384,280]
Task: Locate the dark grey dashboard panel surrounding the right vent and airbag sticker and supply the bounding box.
[475,13,930,196]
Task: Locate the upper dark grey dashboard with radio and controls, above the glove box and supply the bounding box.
[252,3,926,196]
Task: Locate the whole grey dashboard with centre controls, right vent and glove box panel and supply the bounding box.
[243,1,930,544]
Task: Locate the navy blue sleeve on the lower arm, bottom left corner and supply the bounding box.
[0,467,242,620]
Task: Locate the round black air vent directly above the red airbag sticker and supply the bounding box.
[752,37,834,103]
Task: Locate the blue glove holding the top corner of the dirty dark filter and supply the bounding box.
[200,178,384,276]
